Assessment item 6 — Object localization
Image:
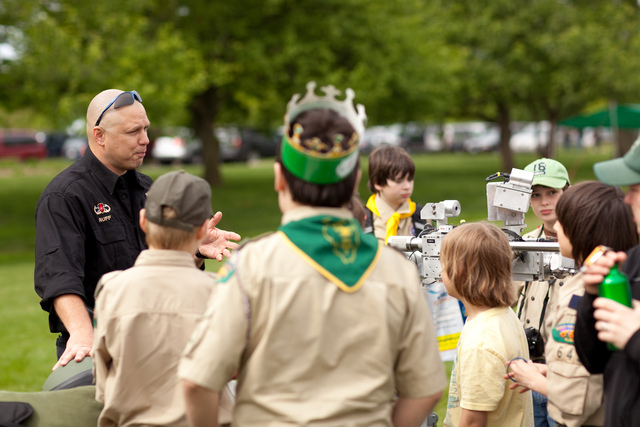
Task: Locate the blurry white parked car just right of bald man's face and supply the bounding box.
[150,127,202,164]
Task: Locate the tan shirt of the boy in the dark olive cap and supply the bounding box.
[93,250,234,427]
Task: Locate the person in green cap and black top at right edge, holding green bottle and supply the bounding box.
[575,139,640,427]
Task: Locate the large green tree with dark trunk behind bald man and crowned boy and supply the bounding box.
[0,0,459,184]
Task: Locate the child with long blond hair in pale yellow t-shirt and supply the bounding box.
[440,222,533,427]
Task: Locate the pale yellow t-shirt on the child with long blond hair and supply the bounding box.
[444,307,533,427]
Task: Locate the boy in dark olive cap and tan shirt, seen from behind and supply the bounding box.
[93,171,230,427]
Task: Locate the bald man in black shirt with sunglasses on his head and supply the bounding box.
[34,89,240,369]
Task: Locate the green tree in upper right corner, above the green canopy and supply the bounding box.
[441,0,640,170]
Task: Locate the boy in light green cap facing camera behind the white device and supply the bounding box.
[516,158,571,427]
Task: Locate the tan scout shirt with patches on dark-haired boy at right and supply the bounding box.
[545,274,604,427]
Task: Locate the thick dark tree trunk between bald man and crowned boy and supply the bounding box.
[190,87,223,187]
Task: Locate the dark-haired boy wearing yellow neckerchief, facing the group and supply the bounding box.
[364,145,425,242]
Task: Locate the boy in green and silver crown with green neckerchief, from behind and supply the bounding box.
[179,82,447,426]
